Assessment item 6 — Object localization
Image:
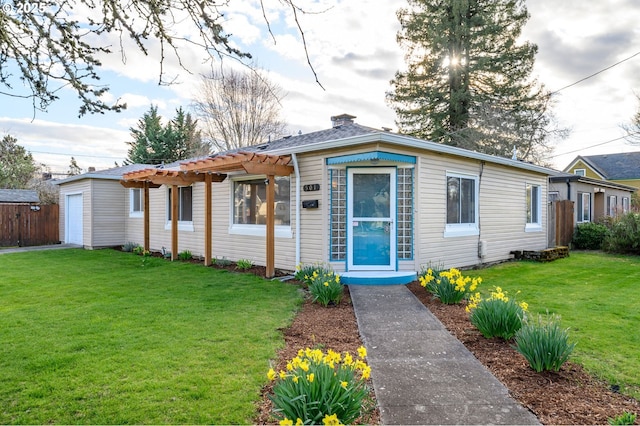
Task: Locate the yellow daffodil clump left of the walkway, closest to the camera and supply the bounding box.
[267,347,371,424]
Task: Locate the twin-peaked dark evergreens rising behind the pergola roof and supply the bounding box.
[125,105,210,164]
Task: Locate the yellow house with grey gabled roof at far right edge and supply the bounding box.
[564,152,640,188]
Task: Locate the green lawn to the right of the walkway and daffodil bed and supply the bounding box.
[477,252,640,399]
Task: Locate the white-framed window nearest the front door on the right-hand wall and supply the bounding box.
[444,172,478,237]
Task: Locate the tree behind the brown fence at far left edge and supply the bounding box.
[0,135,38,189]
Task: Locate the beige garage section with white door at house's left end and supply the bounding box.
[55,164,151,249]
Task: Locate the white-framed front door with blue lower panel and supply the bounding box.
[347,167,396,271]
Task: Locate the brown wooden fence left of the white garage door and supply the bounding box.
[0,204,60,247]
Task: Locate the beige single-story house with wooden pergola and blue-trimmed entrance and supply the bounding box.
[59,114,551,282]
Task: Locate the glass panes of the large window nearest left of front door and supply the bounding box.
[233,176,291,225]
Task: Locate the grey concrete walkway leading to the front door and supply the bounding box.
[349,285,539,425]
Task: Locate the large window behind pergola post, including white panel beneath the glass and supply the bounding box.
[229,176,292,238]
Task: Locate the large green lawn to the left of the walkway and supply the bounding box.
[0,250,301,424]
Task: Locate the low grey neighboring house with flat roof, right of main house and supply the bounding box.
[549,172,636,224]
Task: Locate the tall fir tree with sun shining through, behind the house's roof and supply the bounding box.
[387,0,563,162]
